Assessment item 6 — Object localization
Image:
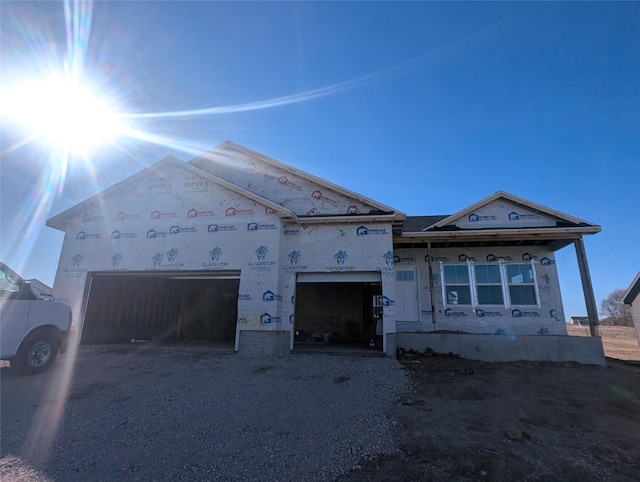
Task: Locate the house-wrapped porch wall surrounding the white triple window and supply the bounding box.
[394,246,567,335]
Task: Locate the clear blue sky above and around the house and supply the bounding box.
[0,1,640,316]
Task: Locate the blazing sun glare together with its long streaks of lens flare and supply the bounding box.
[0,0,482,468]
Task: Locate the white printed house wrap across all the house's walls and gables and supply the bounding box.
[47,148,592,353]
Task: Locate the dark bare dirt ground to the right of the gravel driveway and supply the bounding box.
[340,327,640,481]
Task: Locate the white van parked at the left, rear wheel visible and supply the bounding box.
[0,263,71,375]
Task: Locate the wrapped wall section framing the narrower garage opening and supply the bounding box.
[280,223,395,348]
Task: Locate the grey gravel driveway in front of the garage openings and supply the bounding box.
[0,346,409,481]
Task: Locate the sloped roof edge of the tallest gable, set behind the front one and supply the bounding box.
[189,140,406,220]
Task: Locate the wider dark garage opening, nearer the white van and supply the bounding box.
[80,271,240,346]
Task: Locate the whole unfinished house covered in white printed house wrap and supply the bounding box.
[47,142,600,360]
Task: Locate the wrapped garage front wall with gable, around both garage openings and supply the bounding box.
[54,160,395,350]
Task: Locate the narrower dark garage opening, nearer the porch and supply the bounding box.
[294,272,382,350]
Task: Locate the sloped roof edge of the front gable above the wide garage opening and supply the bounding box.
[46,156,296,231]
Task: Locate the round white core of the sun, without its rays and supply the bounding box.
[0,76,121,154]
